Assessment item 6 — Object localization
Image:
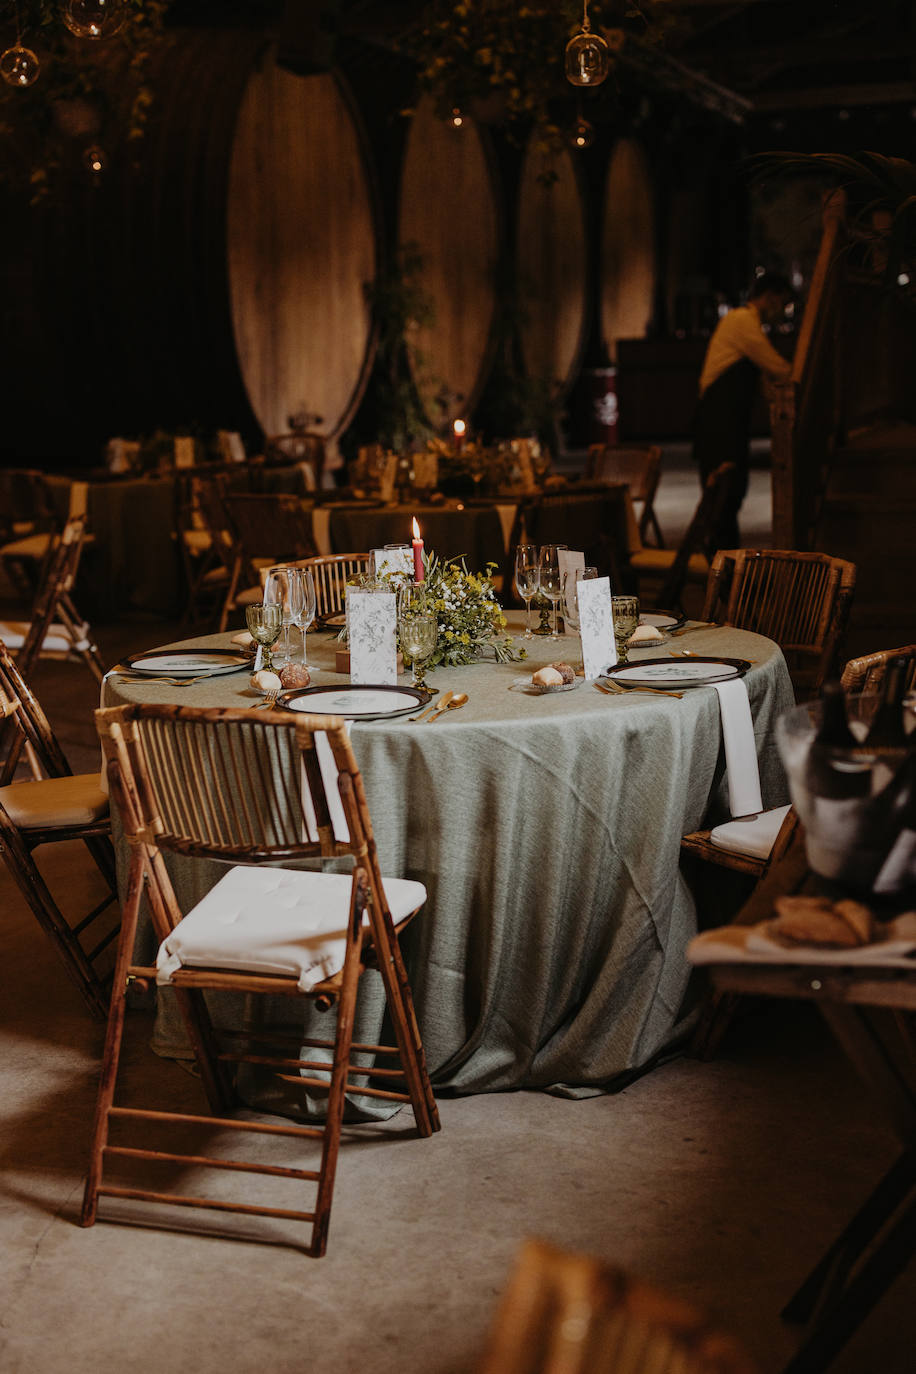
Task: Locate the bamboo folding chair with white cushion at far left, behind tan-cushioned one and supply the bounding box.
[0,515,104,683]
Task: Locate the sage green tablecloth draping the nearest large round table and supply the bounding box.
[103,616,794,1095]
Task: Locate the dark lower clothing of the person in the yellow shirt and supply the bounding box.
[694,359,759,548]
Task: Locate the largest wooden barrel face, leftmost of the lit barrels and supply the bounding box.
[228,60,376,434]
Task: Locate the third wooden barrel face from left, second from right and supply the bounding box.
[516,144,588,390]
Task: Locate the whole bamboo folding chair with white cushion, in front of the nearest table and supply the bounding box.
[82,705,439,1256]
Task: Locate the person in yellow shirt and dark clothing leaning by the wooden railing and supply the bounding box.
[694,272,794,548]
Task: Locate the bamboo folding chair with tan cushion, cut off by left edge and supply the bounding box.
[0,643,118,1020]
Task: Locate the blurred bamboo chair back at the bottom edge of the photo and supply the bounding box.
[479,1241,754,1374]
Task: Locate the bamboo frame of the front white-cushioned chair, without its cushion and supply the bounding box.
[81,705,439,1256]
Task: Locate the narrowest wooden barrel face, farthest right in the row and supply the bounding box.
[602,139,655,359]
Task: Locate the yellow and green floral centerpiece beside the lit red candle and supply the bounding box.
[423,554,525,668]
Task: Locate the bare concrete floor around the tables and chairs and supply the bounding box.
[0,445,916,1374]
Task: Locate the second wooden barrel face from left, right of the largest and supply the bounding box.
[398,99,499,418]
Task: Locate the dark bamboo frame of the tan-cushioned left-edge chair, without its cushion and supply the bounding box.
[0,642,118,1020]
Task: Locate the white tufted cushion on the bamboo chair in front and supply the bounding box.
[157,866,426,992]
